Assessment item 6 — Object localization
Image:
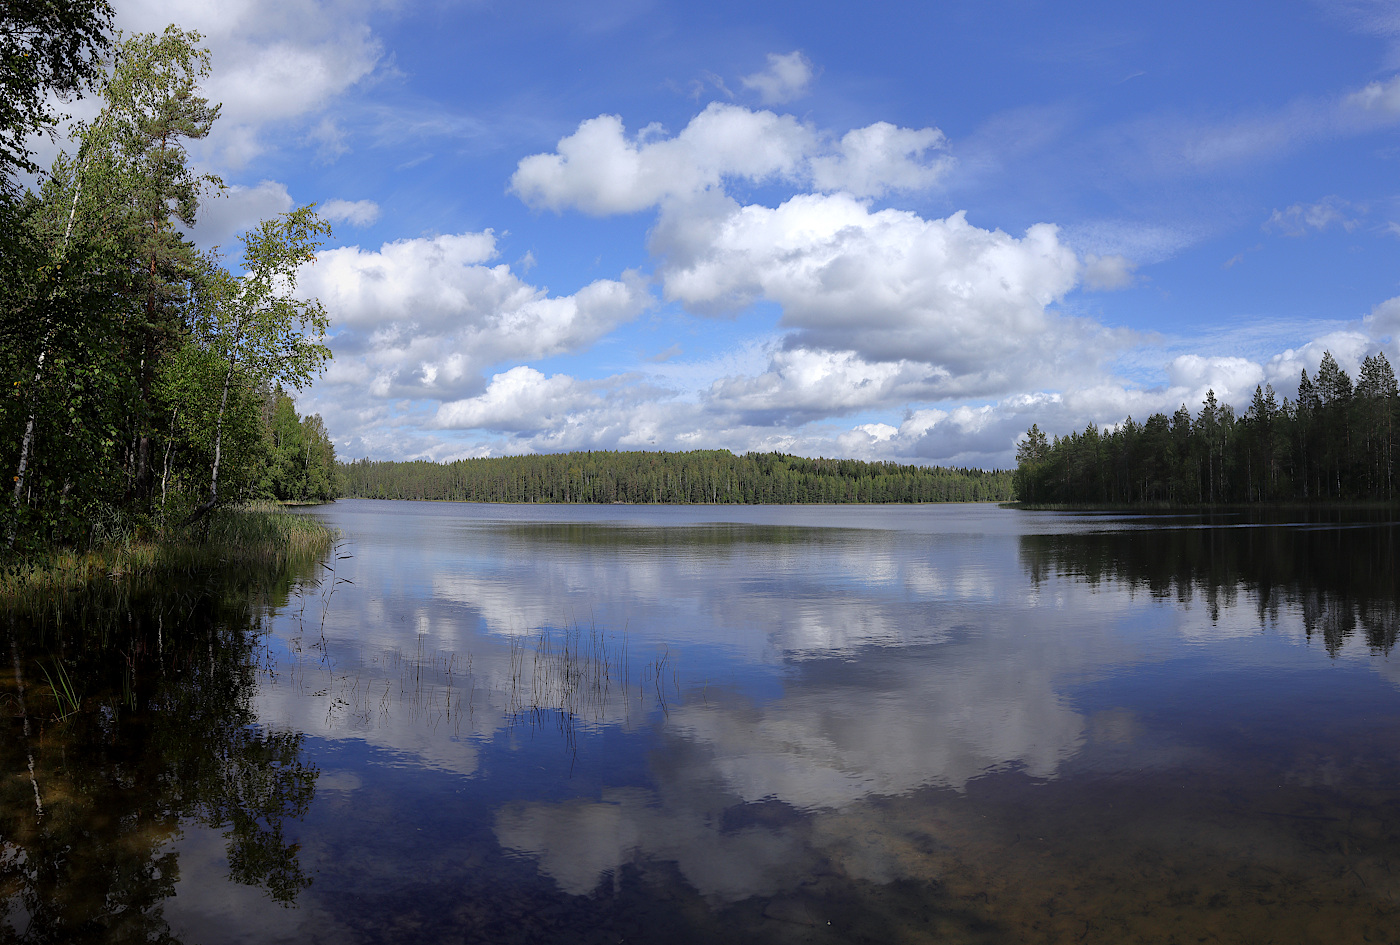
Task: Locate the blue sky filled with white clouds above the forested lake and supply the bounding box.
[70,0,1400,468]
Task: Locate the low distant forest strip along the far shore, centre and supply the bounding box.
[339,449,1011,505]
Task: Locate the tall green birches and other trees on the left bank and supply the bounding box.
[0,14,335,552]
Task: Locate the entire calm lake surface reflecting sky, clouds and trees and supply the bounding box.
[0,500,1400,945]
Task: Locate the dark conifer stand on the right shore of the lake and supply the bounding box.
[1015,351,1400,505]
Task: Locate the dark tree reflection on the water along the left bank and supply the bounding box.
[0,543,321,942]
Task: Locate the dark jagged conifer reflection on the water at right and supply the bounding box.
[1021,514,1400,654]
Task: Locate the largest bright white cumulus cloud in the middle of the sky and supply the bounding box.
[654,195,1105,393]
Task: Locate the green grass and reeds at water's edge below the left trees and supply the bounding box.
[0,503,335,616]
